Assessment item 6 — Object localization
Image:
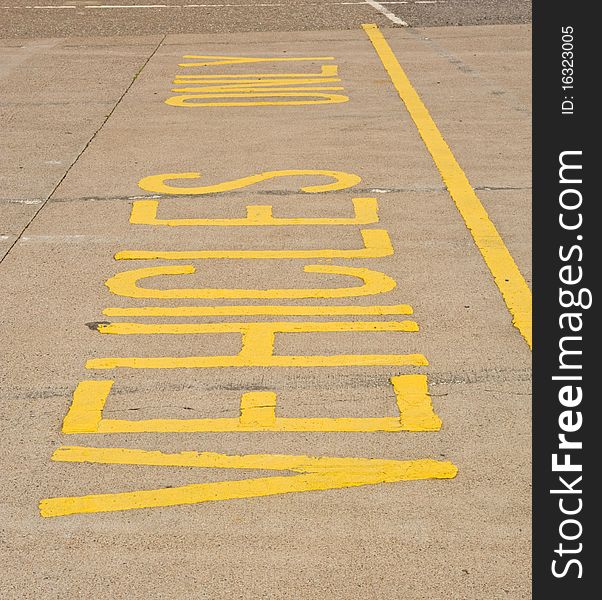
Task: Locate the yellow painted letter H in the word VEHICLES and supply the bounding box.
[86,321,428,369]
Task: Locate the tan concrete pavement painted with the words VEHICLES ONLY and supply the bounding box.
[0,9,530,600]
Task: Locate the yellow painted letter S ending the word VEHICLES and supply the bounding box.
[138,169,361,196]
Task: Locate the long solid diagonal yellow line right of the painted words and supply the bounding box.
[362,24,532,348]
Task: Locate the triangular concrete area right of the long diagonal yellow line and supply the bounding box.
[388,25,531,281]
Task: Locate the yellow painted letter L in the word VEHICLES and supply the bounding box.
[115,229,393,260]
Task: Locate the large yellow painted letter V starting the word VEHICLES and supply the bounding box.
[39,446,458,517]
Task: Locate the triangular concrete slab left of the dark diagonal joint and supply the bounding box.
[0,37,160,251]
